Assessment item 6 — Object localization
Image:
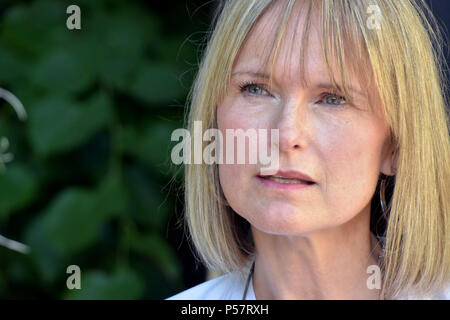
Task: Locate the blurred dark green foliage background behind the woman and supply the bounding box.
[0,0,450,299]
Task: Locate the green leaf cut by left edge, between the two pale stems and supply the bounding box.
[0,163,37,219]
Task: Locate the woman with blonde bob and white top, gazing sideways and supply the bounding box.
[170,0,450,299]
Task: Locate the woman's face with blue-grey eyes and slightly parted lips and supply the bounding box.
[217,3,392,234]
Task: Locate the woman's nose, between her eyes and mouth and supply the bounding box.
[276,98,309,153]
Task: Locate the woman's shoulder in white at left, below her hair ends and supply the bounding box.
[166,272,245,300]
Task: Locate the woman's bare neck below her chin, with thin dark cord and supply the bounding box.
[252,209,380,300]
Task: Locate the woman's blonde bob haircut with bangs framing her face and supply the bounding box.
[185,0,450,299]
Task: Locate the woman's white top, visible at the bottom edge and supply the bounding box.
[167,271,450,300]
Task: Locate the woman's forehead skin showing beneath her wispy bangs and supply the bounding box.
[232,1,366,91]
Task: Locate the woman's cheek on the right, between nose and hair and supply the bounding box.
[317,119,385,212]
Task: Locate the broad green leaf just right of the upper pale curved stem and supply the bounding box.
[28,94,112,157]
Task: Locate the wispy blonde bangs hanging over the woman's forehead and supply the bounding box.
[261,0,374,112]
